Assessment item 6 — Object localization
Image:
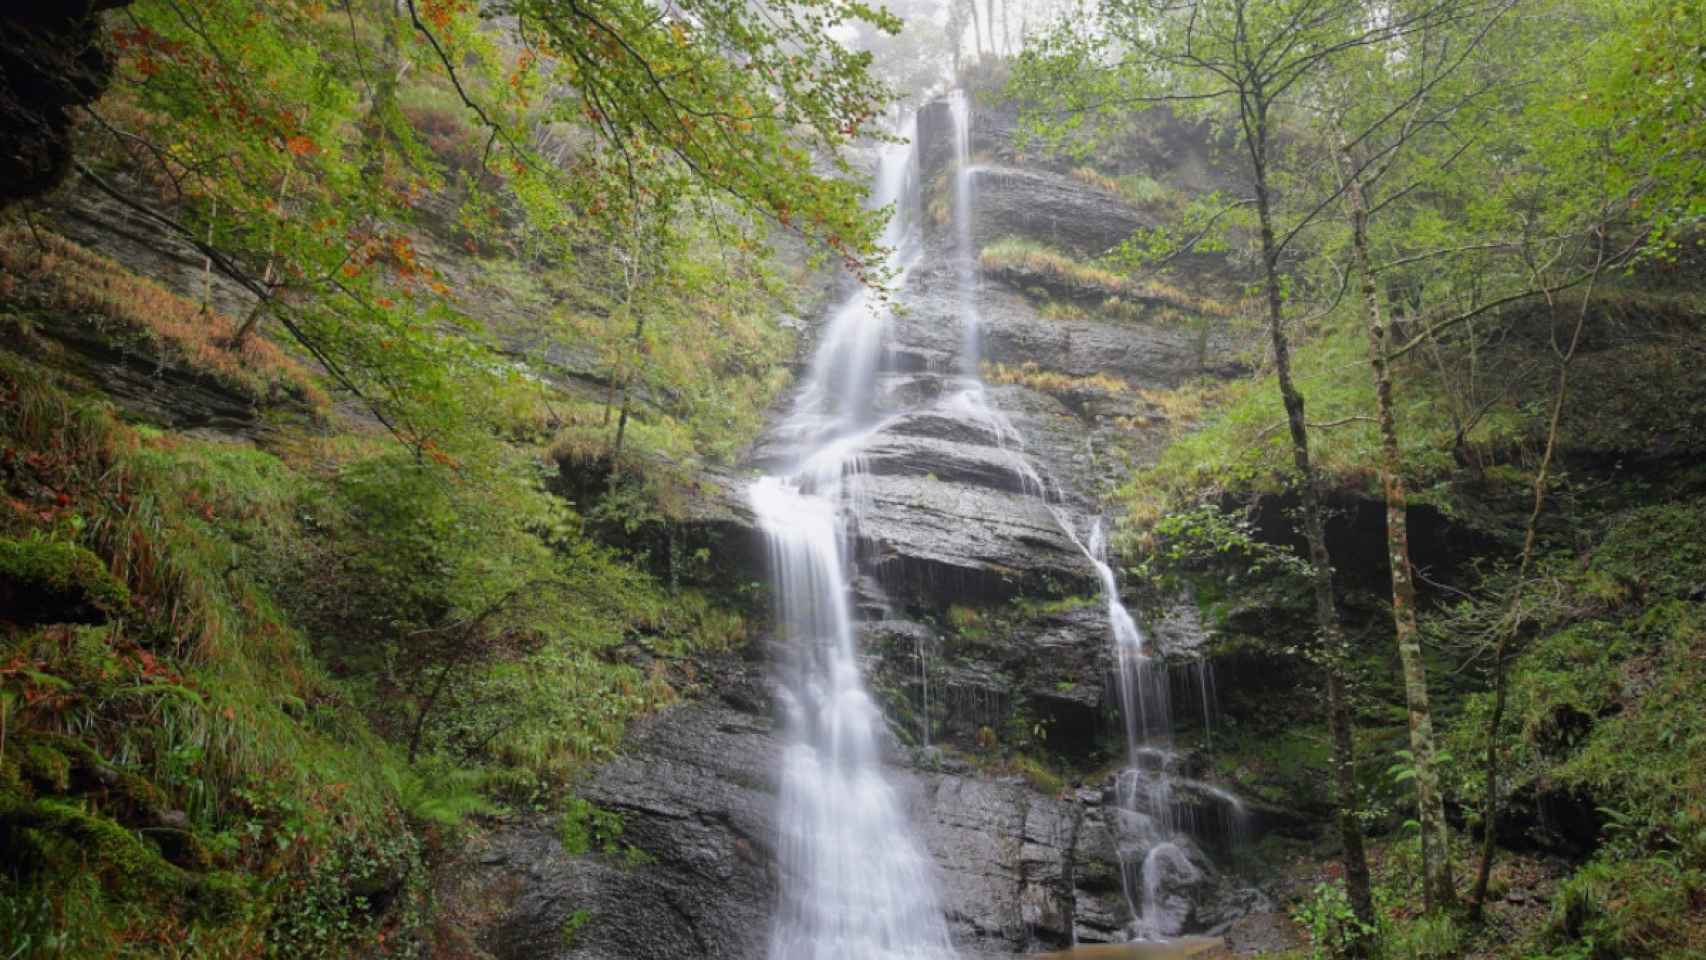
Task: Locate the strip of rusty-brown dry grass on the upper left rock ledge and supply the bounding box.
[0,225,331,408]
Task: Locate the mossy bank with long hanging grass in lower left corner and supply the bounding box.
[0,361,420,957]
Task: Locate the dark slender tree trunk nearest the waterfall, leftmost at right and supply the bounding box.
[1250,135,1375,953]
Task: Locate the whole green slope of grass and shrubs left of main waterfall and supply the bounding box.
[0,334,744,957]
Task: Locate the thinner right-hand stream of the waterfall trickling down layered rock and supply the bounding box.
[949,92,1244,940]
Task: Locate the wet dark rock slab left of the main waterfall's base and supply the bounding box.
[481,703,780,960]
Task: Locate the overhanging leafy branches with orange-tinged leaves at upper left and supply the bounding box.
[64,0,897,470]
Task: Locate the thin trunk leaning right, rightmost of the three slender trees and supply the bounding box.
[1469,237,1605,922]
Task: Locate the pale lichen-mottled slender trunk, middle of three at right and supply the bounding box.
[1339,148,1457,911]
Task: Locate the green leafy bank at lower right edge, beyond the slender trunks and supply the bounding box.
[1419,500,1706,960]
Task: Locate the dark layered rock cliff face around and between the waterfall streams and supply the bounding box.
[446,92,1296,960]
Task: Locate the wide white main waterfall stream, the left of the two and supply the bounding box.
[749,112,952,960]
